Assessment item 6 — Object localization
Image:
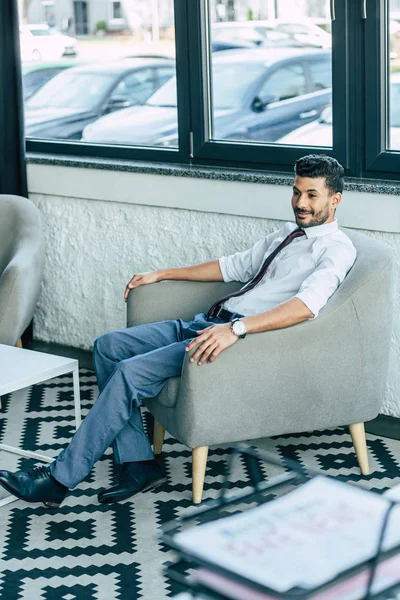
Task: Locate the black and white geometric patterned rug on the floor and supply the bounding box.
[0,370,400,600]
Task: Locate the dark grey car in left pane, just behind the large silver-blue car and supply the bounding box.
[25,58,175,140]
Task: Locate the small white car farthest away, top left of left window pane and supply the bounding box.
[20,25,78,62]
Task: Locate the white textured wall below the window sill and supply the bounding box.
[28,164,400,417]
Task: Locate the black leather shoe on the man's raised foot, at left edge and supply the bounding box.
[0,467,68,508]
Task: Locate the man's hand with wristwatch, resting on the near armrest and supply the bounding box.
[186,323,239,365]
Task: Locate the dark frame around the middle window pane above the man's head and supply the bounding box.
[184,0,349,171]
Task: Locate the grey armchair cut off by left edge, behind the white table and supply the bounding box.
[0,195,44,346]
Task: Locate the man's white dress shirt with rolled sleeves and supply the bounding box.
[219,219,356,318]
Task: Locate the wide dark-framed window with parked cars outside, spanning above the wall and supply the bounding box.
[21,0,400,179]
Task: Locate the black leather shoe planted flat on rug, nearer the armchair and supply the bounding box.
[98,459,167,504]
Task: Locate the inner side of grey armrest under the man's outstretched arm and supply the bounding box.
[127,281,243,327]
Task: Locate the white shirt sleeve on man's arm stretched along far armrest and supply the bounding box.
[219,231,281,283]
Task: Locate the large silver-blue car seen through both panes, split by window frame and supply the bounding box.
[83,48,331,146]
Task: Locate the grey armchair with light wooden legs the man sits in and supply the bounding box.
[127,231,393,504]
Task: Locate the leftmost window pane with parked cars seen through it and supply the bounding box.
[21,0,178,155]
